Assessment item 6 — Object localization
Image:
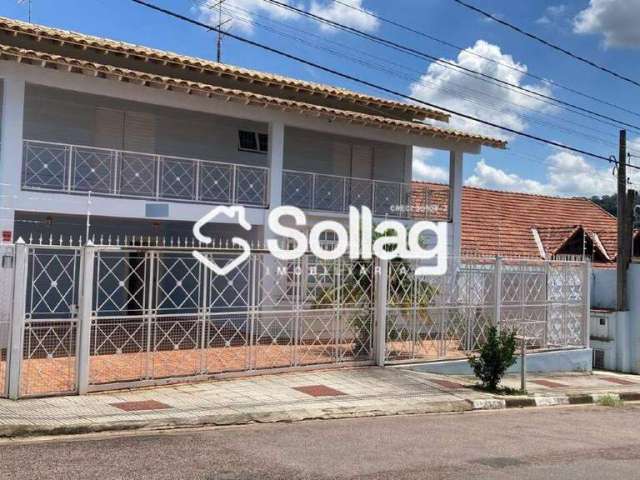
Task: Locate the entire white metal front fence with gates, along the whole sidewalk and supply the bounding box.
[0,238,589,398]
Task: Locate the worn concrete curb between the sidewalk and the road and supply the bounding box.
[0,392,640,438]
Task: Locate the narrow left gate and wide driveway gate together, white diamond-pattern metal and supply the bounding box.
[8,245,374,396]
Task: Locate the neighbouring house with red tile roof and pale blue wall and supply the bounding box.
[412,181,640,371]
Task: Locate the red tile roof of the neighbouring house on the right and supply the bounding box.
[411,182,617,261]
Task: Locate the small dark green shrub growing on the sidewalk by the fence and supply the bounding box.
[469,325,516,390]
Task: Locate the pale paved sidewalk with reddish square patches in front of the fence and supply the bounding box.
[0,367,640,437]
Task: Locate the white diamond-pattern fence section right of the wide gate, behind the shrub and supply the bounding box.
[385,258,589,362]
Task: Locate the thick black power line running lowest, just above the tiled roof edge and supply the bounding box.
[131,0,640,169]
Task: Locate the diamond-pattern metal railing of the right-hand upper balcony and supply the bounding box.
[282,170,449,221]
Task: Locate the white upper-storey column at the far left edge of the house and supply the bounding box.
[0,76,25,236]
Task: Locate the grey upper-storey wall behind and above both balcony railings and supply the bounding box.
[24,84,410,181]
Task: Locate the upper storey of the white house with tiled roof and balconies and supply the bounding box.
[0,18,505,252]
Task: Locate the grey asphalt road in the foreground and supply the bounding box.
[0,406,640,480]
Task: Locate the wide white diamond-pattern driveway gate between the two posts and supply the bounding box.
[88,248,373,389]
